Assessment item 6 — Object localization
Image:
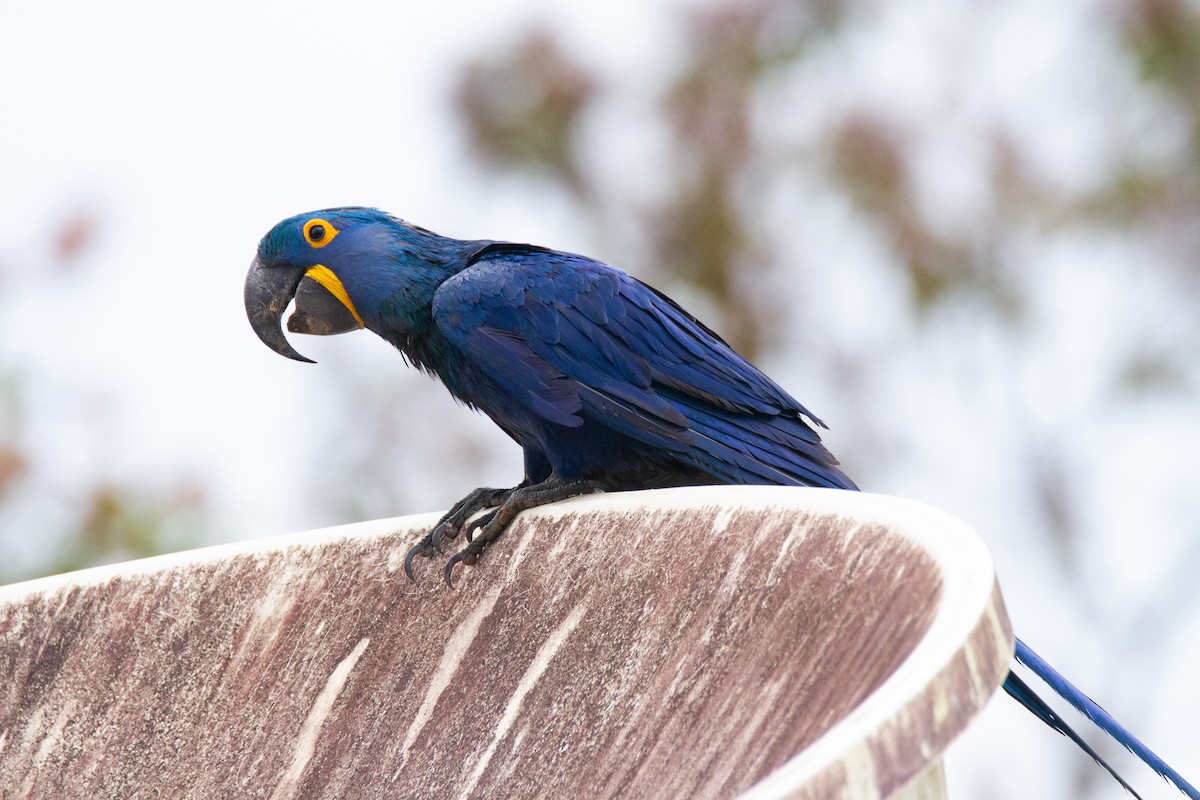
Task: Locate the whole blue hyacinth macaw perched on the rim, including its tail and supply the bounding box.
[245,207,1200,800]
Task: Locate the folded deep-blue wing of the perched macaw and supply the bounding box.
[433,245,854,488]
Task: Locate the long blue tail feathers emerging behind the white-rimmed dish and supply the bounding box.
[1004,639,1200,800]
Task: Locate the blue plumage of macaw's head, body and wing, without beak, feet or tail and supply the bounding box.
[259,209,854,489]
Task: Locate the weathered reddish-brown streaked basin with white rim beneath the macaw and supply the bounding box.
[0,487,1013,799]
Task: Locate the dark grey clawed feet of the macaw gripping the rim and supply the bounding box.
[404,476,605,587]
